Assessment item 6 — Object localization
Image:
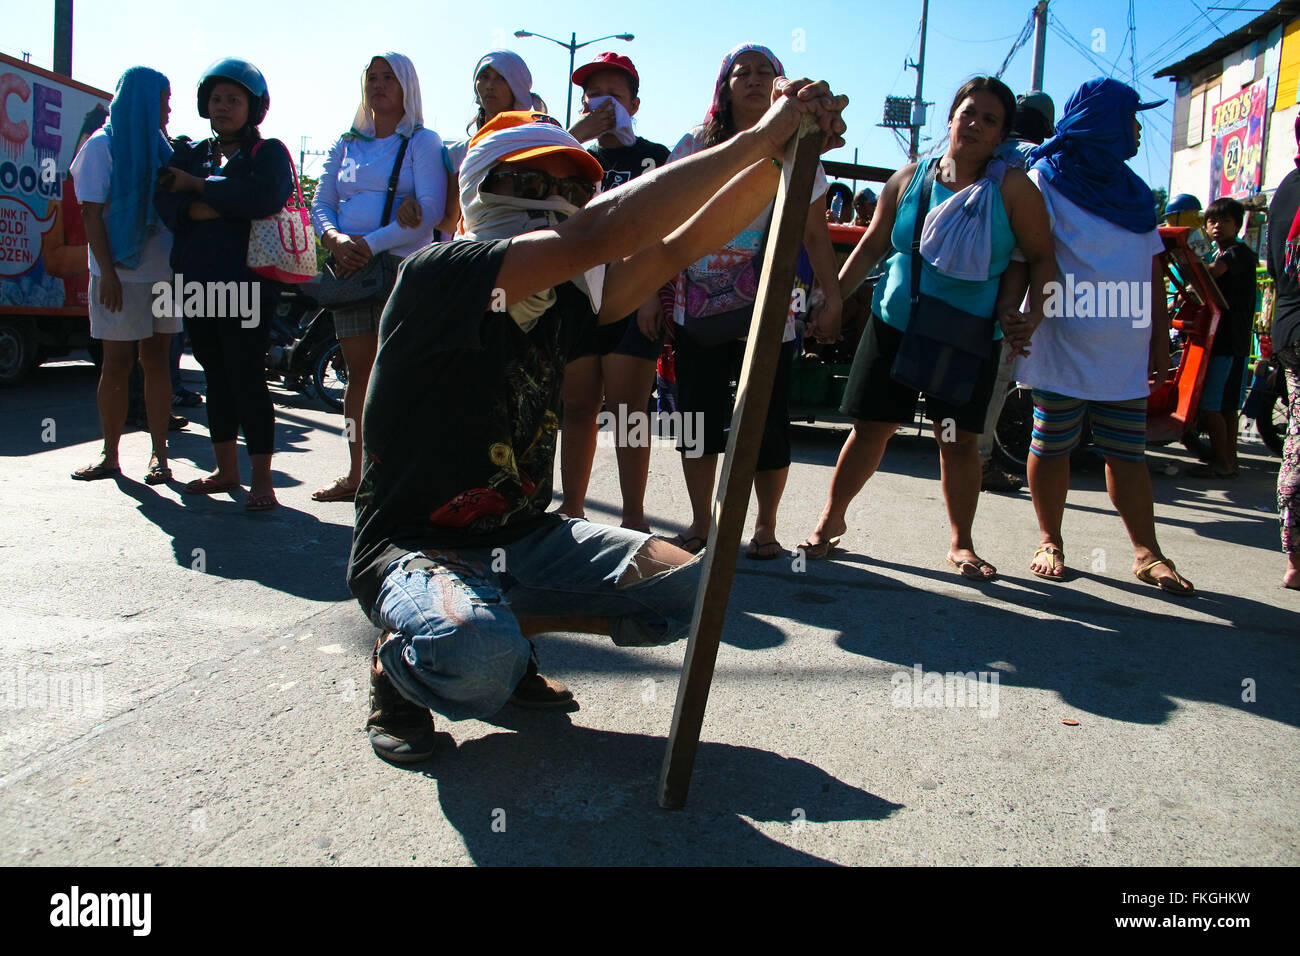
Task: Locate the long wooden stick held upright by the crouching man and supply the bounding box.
[659,120,822,810]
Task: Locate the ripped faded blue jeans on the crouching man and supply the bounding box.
[371,519,702,721]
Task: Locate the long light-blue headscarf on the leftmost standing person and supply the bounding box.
[104,66,172,269]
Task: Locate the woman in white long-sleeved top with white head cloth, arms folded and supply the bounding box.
[312,52,447,501]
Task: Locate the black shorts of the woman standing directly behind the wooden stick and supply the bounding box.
[675,325,794,471]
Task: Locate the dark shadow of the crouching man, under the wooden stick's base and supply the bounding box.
[395,711,902,866]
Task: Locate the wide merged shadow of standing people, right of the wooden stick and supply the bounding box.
[733,548,1300,726]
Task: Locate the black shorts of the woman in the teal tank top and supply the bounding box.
[840,313,1002,434]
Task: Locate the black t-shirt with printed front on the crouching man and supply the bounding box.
[347,239,595,613]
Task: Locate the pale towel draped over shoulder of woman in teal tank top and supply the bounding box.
[920,159,1006,282]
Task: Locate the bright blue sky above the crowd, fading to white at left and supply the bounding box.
[0,0,1268,186]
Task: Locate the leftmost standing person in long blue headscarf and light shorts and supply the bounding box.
[70,66,181,484]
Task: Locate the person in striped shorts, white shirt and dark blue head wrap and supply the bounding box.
[1017,79,1195,597]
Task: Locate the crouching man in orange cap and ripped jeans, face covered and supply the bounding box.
[348,79,848,762]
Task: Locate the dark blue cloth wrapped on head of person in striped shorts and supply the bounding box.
[1030,77,1156,233]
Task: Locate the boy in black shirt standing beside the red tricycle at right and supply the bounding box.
[1187,198,1260,477]
